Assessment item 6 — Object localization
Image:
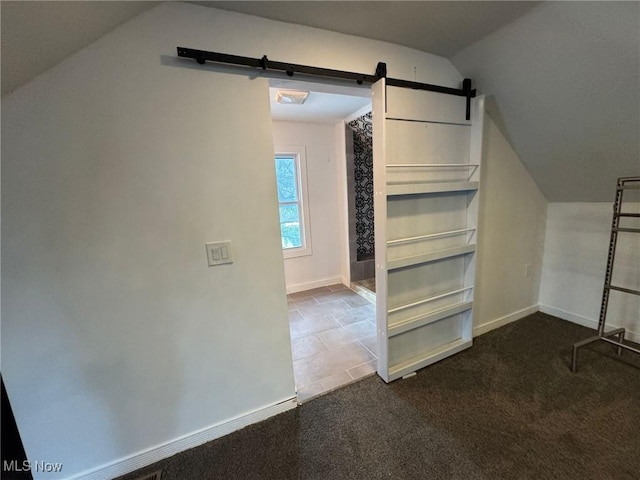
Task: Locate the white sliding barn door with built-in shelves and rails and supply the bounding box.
[372,79,484,382]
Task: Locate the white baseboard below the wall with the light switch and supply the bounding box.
[67,397,298,480]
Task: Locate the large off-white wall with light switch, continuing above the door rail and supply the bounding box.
[2,2,468,479]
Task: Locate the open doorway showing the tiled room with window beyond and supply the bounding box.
[270,79,377,402]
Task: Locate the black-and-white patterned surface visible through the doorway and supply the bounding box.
[349,113,375,260]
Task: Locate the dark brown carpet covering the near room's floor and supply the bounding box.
[122,313,640,480]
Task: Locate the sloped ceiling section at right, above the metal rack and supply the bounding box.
[451,2,640,202]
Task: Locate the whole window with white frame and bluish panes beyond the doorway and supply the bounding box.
[275,147,311,258]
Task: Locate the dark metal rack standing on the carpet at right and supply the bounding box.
[571,177,640,373]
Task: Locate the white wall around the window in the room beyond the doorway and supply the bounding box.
[273,122,344,292]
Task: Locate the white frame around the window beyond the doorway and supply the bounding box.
[273,146,313,259]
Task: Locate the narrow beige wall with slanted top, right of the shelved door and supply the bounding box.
[474,115,547,333]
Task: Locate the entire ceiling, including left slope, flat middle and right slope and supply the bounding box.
[0,0,640,202]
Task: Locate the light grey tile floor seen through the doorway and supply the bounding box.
[287,285,377,402]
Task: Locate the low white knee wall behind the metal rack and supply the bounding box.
[540,202,640,342]
